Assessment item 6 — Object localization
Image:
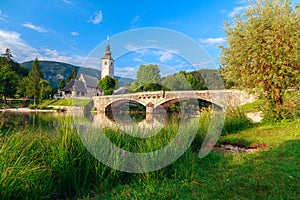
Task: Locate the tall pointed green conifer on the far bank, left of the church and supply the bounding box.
[25,58,43,105]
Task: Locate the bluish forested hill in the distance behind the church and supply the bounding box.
[21,61,133,88]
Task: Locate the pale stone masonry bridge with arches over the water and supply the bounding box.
[93,90,255,113]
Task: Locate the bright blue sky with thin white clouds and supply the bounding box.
[0,0,248,77]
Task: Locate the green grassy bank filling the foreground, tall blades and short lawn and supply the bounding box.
[0,113,300,199]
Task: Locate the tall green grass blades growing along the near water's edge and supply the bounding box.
[0,108,255,199]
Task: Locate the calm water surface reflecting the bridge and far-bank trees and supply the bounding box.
[0,108,199,137]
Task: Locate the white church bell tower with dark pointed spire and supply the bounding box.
[100,38,114,79]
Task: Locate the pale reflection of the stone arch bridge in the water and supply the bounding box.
[70,101,199,137]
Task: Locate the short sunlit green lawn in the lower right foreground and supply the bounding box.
[99,120,300,199]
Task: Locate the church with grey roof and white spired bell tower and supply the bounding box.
[58,40,114,98]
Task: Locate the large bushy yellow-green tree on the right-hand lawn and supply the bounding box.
[221,0,300,121]
